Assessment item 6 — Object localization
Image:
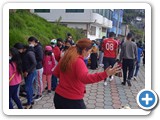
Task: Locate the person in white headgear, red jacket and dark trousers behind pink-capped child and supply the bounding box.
[51,39,61,91]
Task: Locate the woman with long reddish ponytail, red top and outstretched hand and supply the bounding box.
[53,38,120,109]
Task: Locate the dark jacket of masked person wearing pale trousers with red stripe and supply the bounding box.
[34,44,43,69]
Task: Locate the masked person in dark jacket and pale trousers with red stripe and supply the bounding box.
[28,36,43,101]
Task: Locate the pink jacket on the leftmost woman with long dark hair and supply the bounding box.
[9,62,22,86]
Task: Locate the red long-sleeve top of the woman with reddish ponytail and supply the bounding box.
[53,56,107,100]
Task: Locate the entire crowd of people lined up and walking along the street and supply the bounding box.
[9,32,145,109]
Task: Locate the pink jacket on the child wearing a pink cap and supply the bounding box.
[43,55,55,75]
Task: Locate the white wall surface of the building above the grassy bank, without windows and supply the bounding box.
[31,9,112,40]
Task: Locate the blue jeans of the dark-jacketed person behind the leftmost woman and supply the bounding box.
[25,70,37,105]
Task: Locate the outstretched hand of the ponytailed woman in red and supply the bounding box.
[105,65,121,76]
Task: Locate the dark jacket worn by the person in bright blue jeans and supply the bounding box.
[22,47,37,74]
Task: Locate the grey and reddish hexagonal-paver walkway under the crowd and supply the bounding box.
[18,65,145,109]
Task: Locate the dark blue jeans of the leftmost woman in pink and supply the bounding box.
[9,84,23,109]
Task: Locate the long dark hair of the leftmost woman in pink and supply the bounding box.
[10,48,22,74]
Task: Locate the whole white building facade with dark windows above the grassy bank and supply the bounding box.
[30,9,113,40]
